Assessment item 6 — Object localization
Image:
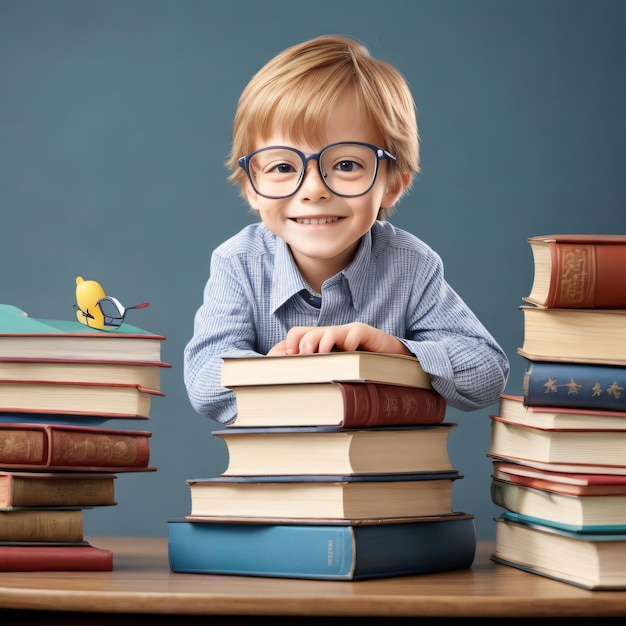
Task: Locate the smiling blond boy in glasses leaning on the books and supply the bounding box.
[184,36,509,423]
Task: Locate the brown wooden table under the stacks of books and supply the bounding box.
[0,537,626,626]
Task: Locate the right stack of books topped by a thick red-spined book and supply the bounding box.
[489,235,626,589]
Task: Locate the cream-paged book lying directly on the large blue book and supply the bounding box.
[187,471,461,520]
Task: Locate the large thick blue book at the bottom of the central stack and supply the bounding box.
[168,514,476,581]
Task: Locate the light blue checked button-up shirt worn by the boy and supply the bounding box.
[184,221,509,423]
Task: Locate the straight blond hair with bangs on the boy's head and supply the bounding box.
[226,35,419,214]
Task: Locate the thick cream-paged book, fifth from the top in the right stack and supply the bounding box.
[490,415,626,466]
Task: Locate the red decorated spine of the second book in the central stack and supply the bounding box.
[337,382,446,428]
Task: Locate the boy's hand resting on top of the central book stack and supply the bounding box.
[267,322,411,356]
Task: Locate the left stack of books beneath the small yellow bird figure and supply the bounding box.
[0,304,171,571]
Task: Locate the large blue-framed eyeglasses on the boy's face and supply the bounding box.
[239,141,396,200]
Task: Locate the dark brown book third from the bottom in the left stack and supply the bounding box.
[0,471,116,508]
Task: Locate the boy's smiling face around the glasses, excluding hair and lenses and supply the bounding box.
[246,95,402,285]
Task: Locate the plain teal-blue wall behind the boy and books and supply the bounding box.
[0,0,626,539]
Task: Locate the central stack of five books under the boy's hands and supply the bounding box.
[168,352,476,580]
